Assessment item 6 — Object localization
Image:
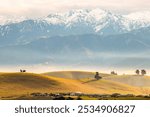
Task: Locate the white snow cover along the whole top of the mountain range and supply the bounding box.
[0,9,150,32]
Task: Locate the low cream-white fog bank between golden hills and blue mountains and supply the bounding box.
[0,64,150,75]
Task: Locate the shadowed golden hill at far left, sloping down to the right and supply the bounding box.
[0,73,105,96]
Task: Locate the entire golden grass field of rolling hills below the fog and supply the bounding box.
[0,71,150,97]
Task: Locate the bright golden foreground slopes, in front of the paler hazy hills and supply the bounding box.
[0,73,149,96]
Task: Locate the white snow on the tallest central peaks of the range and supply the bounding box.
[45,9,127,32]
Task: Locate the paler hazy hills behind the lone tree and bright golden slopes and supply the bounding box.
[44,71,150,87]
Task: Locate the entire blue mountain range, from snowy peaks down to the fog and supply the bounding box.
[0,9,150,67]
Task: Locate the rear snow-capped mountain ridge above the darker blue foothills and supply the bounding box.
[0,9,150,46]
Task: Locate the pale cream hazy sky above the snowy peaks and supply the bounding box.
[0,0,150,16]
